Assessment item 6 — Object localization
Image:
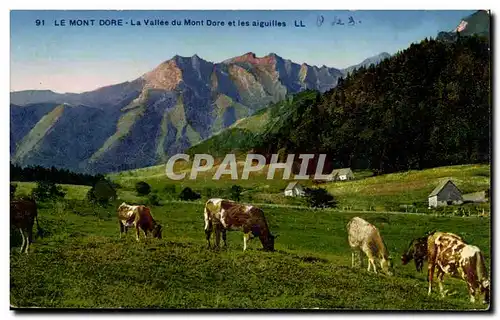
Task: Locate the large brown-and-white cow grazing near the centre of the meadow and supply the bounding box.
[204,198,278,251]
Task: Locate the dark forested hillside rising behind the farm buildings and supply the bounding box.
[192,36,491,173]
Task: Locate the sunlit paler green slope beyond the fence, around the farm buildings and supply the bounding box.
[109,161,490,214]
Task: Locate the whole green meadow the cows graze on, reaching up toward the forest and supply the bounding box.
[10,165,491,310]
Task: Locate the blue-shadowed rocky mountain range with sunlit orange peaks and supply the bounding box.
[10,52,387,173]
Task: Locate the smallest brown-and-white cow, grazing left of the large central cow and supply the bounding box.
[117,202,162,241]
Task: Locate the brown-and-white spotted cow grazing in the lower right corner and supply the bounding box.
[427,232,490,304]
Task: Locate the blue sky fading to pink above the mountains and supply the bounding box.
[10,10,474,93]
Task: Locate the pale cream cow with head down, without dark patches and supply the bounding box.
[347,217,394,276]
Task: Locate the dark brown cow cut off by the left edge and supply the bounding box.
[10,199,41,253]
